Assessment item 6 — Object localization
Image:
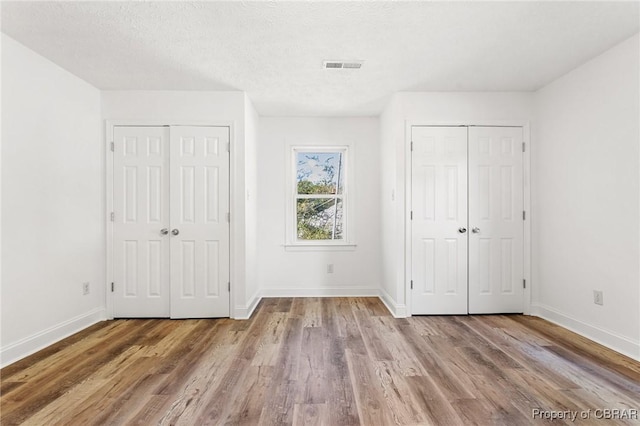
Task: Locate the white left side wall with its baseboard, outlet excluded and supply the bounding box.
[1,35,105,365]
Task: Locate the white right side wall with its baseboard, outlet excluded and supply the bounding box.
[532,35,640,359]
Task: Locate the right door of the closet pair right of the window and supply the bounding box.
[469,127,524,314]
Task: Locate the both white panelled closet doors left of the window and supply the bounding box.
[112,126,230,318]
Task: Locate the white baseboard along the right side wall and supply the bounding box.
[531,304,640,361]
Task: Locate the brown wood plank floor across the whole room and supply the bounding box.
[0,298,640,425]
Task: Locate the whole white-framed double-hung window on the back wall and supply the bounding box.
[288,147,356,245]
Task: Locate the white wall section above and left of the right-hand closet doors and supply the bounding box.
[380,92,533,316]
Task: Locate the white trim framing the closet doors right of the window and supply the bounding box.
[403,120,533,316]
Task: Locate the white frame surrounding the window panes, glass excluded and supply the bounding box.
[285,145,355,250]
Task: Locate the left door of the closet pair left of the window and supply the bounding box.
[113,127,170,317]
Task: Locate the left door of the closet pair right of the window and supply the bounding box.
[411,127,467,315]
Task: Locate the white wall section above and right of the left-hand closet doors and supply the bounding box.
[102,90,252,318]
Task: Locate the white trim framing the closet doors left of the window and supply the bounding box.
[103,119,235,320]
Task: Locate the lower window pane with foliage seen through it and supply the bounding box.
[296,198,344,240]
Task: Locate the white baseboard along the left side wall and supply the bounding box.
[0,307,107,368]
